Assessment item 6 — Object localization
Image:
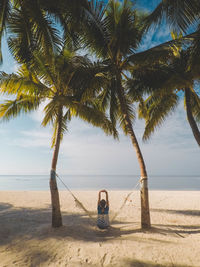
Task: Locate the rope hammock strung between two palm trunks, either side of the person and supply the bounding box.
[56,173,141,223]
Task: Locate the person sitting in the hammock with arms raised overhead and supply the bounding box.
[97,190,110,229]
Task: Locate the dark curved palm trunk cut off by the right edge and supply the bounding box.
[185,88,200,146]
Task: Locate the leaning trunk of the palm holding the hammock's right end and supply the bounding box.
[118,74,151,229]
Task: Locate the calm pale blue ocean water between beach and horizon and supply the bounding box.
[0,175,200,191]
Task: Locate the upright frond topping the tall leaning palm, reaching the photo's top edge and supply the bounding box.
[106,1,145,58]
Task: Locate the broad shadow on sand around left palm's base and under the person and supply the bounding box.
[0,206,141,246]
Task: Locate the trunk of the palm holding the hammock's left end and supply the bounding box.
[50,109,62,227]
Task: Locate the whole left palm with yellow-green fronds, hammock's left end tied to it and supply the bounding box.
[0,49,117,227]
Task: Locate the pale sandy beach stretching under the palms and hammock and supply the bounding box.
[0,191,200,267]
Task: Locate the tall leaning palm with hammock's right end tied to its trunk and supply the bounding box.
[81,0,151,228]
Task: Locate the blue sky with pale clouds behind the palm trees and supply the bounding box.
[0,0,200,175]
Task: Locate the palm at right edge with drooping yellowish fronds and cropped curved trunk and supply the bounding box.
[129,49,200,145]
